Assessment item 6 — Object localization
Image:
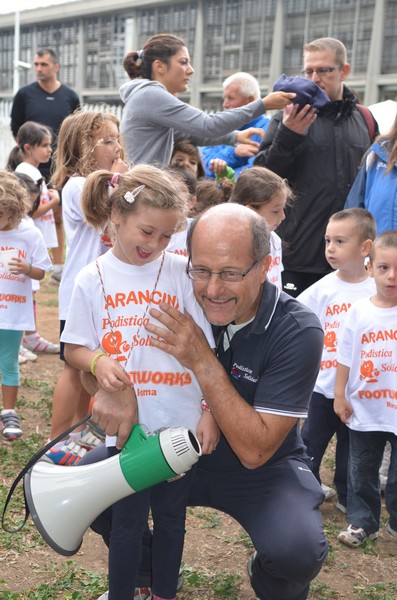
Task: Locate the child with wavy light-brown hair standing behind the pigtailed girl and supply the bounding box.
[46,111,127,465]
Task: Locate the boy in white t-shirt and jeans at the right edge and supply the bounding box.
[334,230,397,547]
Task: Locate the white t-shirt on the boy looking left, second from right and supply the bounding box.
[297,271,376,398]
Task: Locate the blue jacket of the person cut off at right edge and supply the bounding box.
[345,140,397,235]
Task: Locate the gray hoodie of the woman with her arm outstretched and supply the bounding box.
[120,79,265,165]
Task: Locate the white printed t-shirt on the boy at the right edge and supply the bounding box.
[336,298,397,435]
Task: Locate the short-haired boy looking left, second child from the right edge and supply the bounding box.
[298,208,376,513]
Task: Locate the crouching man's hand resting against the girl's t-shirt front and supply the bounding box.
[145,303,213,372]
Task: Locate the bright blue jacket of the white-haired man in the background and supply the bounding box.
[201,115,270,179]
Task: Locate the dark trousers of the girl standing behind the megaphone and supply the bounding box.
[79,446,194,600]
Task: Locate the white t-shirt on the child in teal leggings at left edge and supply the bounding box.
[0,217,51,331]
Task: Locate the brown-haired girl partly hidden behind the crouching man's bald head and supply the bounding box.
[230,167,293,290]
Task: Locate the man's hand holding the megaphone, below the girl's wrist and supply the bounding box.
[92,387,138,450]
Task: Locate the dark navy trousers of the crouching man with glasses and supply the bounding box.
[89,450,328,600]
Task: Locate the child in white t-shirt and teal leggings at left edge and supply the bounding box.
[0,171,51,440]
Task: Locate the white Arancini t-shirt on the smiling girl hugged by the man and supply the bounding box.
[61,250,215,440]
